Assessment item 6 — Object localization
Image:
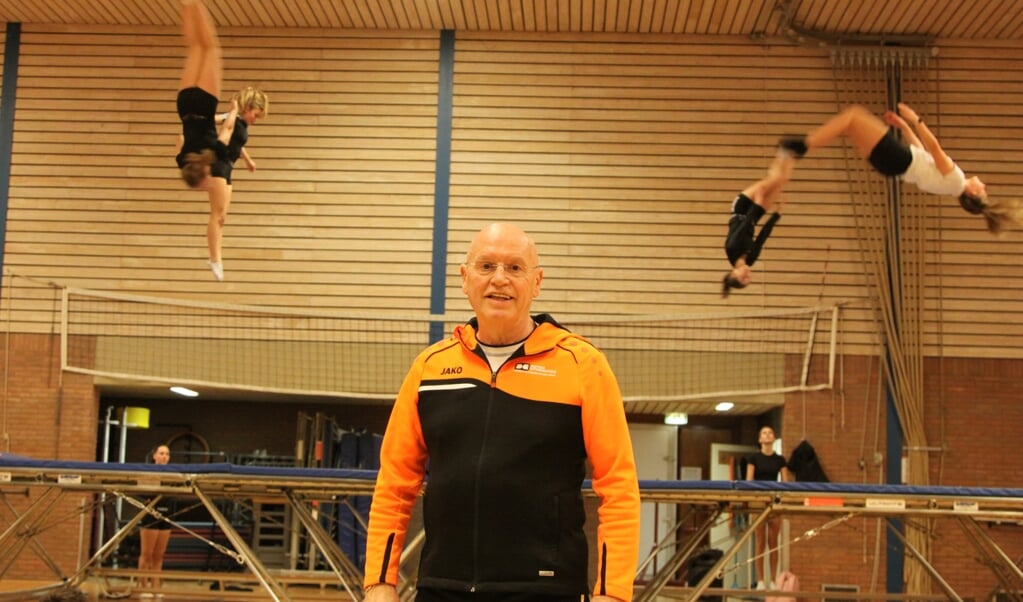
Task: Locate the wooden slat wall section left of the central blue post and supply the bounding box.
[5,27,439,311]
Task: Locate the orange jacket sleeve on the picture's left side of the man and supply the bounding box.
[363,356,427,587]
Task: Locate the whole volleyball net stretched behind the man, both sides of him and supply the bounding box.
[43,289,855,414]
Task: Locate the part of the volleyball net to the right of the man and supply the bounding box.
[566,305,842,414]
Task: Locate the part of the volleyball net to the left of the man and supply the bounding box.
[60,289,435,400]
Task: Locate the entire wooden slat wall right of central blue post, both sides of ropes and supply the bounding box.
[449,33,1023,356]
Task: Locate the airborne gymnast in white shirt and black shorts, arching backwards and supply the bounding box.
[781,102,1023,233]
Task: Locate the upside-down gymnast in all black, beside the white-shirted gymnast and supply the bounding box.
[721,149,795,297]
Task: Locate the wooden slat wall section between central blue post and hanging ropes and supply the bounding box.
[450,34,865,323]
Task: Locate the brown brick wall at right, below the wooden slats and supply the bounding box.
[784,357,1023,600]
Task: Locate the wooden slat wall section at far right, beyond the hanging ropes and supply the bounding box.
[926,40,1023,358]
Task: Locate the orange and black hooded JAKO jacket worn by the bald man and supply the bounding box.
[364,314,639,600]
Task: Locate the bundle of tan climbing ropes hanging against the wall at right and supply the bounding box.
[832,48,933,593]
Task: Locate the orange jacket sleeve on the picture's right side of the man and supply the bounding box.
[580,349,639,600]
